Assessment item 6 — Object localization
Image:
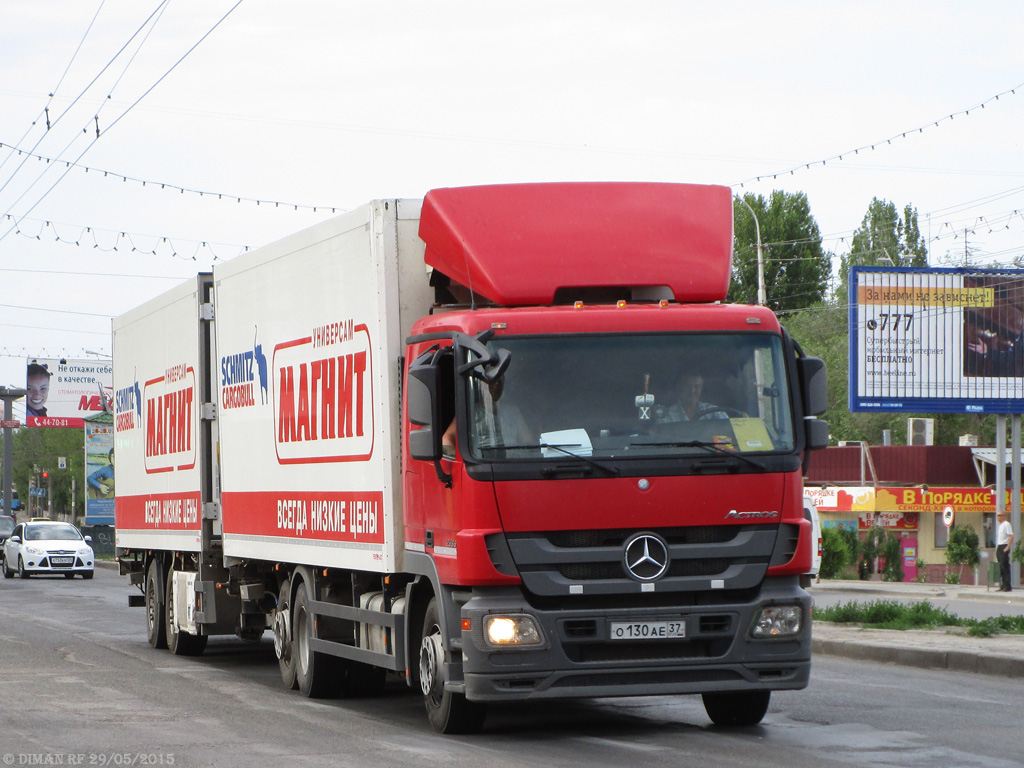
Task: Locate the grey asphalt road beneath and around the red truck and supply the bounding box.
[0,569,1024,768]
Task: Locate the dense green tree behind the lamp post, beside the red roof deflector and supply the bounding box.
[728,189,831,311]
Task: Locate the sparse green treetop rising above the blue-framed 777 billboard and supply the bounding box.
[836,198,928,304]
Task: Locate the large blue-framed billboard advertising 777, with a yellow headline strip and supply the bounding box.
[849,266,1024,414]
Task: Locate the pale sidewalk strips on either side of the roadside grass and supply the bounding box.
[808,580,1024,678]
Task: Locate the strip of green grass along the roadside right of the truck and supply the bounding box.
[814,600,1024,637]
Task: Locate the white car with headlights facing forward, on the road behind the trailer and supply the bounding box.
[3,520,95,579]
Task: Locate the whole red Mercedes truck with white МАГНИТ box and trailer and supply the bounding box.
[114,183,827,733]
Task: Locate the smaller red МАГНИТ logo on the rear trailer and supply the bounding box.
[142,362,199,473]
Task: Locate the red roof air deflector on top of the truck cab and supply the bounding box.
[420,182,732,306]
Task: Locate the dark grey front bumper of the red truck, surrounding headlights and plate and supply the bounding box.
[462,579,811,701]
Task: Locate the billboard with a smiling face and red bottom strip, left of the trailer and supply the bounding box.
[25,357,114,427]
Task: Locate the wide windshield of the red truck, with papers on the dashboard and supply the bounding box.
[468,333,795,461]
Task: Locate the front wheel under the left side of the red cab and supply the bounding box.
[420,597,487,733]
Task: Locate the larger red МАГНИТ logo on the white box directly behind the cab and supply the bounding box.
[271,319,374,464]
